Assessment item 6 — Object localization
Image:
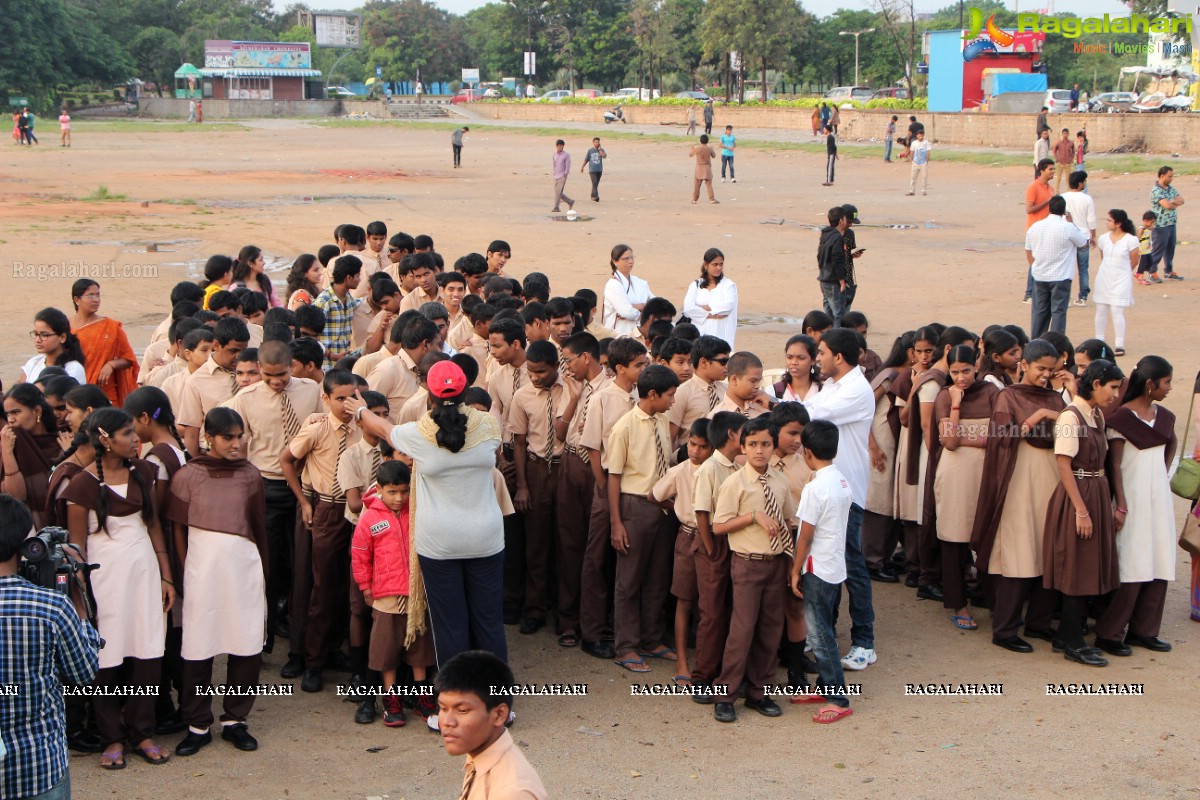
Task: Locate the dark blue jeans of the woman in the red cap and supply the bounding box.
[419,551,509,667]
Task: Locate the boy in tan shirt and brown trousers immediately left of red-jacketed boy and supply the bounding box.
[280,369,362,692]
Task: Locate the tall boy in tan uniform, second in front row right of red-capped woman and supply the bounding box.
[554,333,612,648]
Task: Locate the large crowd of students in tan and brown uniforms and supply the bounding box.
[0,214,1200,782]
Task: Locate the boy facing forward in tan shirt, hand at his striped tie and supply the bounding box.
[713,419,796,722]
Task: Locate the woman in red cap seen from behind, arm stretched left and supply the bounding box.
[347,361,508,726]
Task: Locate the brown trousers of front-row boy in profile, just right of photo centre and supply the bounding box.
[613,494,674,656]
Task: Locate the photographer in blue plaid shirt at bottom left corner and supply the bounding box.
[0,494,100,800]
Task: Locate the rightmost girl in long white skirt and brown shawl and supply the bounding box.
[1096,355,1178,656]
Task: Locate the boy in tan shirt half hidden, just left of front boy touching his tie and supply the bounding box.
[691,411,746,704]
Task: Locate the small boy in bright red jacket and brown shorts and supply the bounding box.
[350,461,437,728]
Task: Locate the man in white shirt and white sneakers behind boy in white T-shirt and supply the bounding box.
[805,327,876,669]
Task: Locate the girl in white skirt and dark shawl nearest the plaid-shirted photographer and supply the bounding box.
[62,408,175,770]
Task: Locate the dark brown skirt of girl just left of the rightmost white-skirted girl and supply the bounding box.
[1042,477,1121,597]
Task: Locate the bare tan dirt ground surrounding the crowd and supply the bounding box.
[0,121,1200,800]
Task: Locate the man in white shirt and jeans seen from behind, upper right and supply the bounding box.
[1025,194,1087,339]
